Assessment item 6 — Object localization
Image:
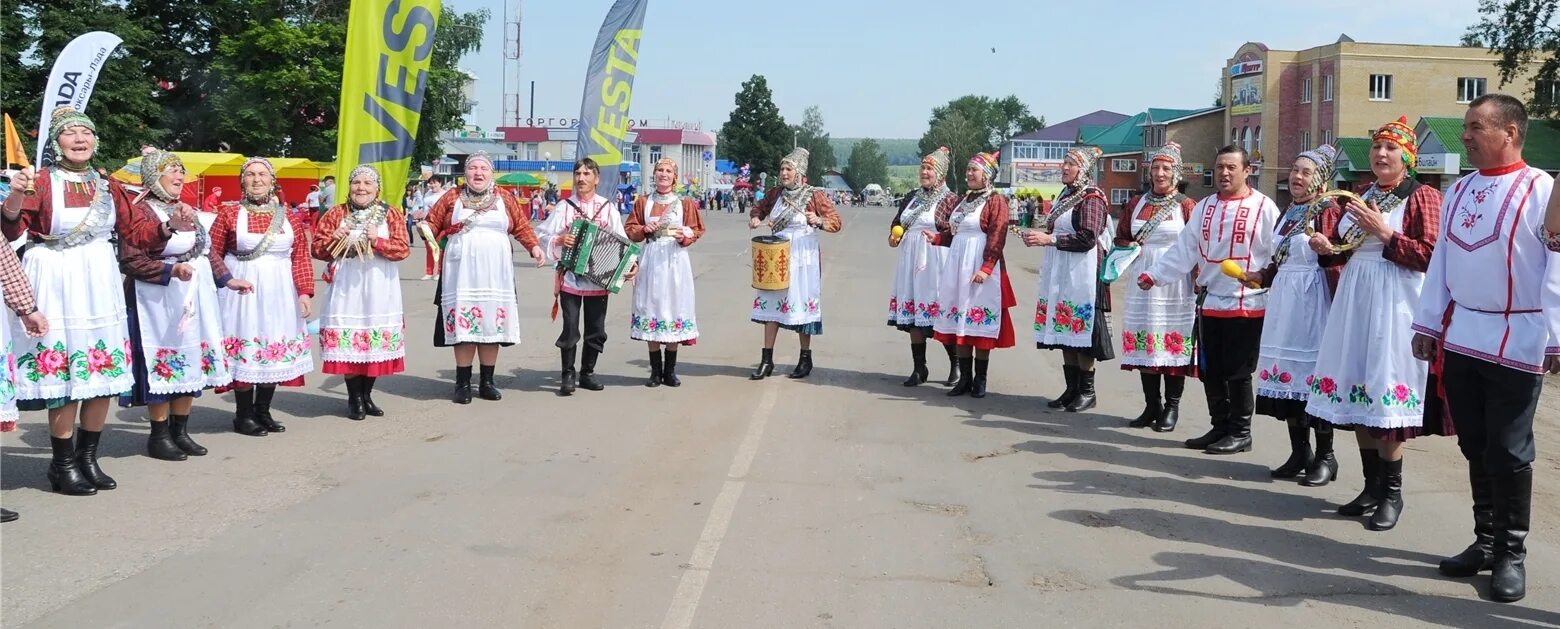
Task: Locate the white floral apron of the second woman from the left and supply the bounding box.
[133,206,232,395]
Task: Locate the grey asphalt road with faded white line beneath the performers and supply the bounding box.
[0,208,1560,627]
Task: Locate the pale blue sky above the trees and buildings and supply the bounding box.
[451,0,1477,137]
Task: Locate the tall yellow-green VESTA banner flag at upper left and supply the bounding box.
[335,0,440,204]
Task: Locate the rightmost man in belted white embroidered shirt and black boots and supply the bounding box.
[1413,94,1560,602]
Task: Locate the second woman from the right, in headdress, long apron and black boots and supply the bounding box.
[1246,145,1342,487]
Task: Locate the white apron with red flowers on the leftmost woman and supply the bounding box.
[9,173,136,400]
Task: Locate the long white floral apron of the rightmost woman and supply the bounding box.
[1306,203,1429,429]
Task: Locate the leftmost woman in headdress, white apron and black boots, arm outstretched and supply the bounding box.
[0,108,178,495]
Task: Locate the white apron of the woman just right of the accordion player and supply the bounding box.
[629,200,699,343]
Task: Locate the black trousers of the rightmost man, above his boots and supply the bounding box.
[1441,351,1544,476]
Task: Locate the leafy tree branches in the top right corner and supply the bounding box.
[1463,0,1560,117]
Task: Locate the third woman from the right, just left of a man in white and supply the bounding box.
[1115,142,1197,432]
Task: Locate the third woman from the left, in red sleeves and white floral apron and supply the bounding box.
[211,158,314,437]
